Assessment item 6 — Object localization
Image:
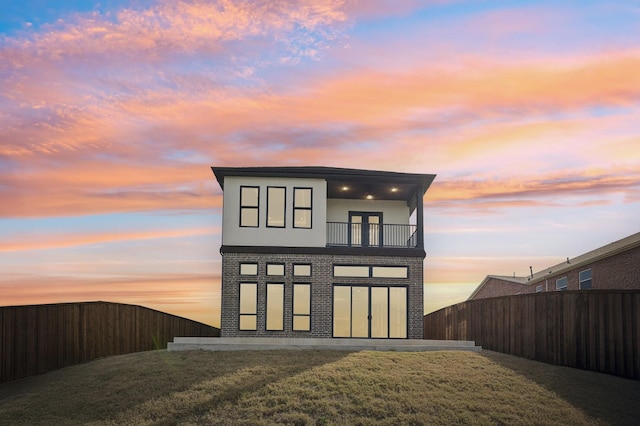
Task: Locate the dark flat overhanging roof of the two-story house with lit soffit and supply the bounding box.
[211,166,436,211]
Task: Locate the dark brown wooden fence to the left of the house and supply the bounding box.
[0,302,220,383]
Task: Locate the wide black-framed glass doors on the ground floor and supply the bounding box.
[333,285,407,339]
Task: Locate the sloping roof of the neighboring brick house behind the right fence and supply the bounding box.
[467,232,640,300]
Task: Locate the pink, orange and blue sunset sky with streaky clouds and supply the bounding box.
[0,0,640,325]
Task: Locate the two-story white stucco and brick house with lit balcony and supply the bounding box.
[212,167,435,339]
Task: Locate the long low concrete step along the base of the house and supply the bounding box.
[167,337,482,352]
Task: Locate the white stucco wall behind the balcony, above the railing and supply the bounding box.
[327,198,409,225]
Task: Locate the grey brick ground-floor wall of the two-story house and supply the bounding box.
[221,252,424,339]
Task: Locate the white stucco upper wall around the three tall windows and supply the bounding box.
[222,176,327,247]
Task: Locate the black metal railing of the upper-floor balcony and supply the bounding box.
[327,222,418,248]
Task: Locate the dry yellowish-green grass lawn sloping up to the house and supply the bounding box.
[0,351,640,425]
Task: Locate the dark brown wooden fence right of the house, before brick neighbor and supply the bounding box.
[424,290,640,379]
